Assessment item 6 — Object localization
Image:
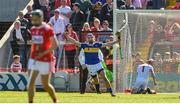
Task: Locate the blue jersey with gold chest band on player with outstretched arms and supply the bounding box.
[81,43,102,65]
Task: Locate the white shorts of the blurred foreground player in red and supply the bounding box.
[28,59,51,75]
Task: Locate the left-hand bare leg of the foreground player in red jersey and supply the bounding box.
[27,70,39,103]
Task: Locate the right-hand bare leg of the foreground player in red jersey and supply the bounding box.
[41,73,57,103]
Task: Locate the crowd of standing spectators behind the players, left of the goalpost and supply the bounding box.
[11,0,113,72]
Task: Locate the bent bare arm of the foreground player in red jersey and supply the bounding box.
[36,36,58,59]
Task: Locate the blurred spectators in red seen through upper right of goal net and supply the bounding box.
[148,15,180,43]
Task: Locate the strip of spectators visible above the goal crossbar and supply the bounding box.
[117,0,180,10]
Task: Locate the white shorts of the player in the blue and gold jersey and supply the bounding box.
[86,63,103,76]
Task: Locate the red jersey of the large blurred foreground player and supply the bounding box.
[30,23,54,62]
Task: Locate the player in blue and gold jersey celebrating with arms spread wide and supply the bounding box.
[65,33,120,96]
